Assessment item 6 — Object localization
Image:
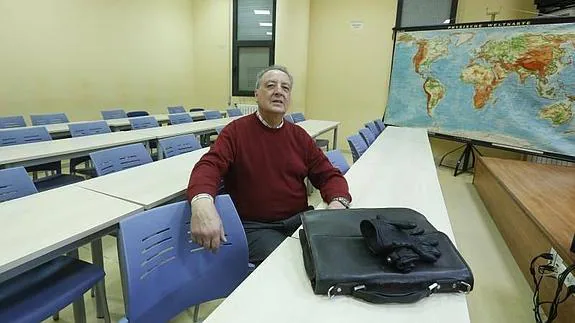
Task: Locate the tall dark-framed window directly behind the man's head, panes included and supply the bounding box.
[232,0,276,96]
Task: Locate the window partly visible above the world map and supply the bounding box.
[395,0,458,28]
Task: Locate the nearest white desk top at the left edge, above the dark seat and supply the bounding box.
[0,185,143,276]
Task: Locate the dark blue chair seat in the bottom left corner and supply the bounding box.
[0,256,105,322]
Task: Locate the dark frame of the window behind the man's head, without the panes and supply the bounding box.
[232,0,277,97]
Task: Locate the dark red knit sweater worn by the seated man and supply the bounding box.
[187,114,351,222]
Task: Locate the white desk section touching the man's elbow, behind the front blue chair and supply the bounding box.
[74,148,209,209]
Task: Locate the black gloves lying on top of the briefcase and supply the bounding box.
[360,216,441,272]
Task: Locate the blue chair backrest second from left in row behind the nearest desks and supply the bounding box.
[90,144,152,176]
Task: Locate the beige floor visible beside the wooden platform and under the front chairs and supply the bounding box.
[46,155,533,323]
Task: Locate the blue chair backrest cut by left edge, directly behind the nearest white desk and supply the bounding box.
[0,166,38,202]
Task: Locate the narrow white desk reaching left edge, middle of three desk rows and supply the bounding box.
[0,131,155,165]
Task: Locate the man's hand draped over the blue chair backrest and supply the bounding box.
[190,198,227,252]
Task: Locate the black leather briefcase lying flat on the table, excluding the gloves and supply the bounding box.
[299,208,473,303]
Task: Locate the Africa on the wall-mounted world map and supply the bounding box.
[461,64,500,109]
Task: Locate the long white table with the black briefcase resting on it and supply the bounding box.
[204,127,469,323]
